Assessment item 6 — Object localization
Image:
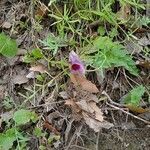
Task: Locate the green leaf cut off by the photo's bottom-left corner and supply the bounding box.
[0,128,16,150]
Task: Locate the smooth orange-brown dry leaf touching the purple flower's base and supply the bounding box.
[70,74,99,93]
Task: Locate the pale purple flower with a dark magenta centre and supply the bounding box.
[69,51,85,75]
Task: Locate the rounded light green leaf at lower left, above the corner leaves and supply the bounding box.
[13,109,38,125]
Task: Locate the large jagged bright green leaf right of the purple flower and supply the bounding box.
[88,37,138,76]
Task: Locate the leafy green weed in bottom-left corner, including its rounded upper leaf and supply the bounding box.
[0,109,38,150]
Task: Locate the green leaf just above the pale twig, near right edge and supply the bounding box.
[124,85,145,106]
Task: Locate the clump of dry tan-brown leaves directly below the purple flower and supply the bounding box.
[65,74,113,132]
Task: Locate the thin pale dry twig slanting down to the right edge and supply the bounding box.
[102,91,150,124]
